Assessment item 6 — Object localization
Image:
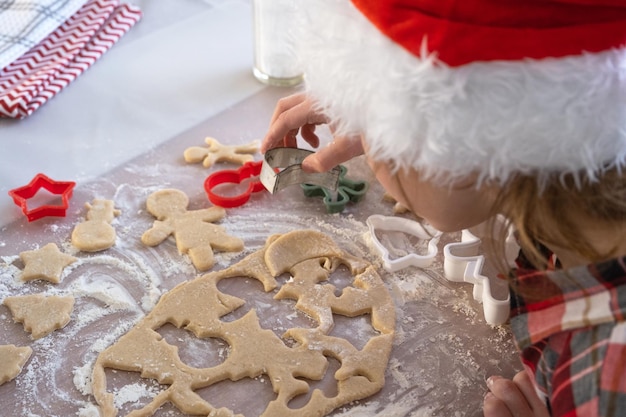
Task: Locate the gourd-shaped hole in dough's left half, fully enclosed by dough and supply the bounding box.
[156,323,230,368]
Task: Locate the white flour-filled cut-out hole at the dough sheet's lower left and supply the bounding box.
[105,369,168,416]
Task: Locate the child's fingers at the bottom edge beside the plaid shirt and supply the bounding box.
[483,371,550,417]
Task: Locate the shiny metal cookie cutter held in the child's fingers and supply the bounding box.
[259,148,341,194]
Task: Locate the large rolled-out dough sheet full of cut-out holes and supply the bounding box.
[92,230,395,417]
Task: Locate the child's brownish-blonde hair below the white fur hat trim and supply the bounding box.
[492,169,626,272]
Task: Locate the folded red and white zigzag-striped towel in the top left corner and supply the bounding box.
[0,0,141,119]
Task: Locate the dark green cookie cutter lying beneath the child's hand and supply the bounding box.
[300,165,369,213]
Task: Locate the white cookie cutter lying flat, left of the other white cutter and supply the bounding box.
[367,214,441,272]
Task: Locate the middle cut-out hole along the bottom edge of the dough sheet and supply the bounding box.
[196,375,276,417]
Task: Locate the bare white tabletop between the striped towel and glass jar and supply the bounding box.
[0,0,264,226]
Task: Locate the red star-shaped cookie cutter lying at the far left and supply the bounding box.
[9,173,76,222]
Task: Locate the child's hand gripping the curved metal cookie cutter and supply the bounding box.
[261,93,363,172]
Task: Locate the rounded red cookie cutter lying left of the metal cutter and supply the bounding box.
[204,161,265,208]
